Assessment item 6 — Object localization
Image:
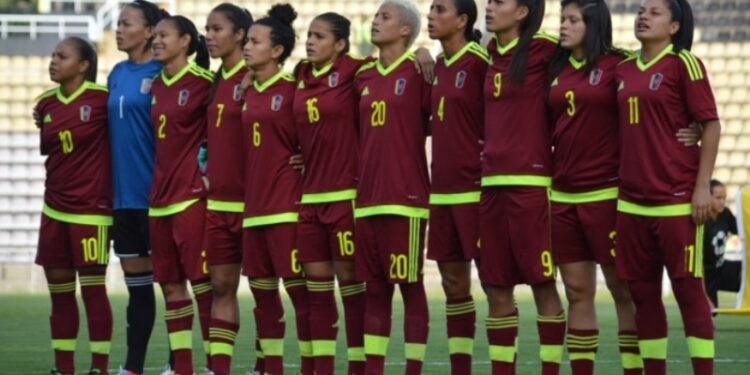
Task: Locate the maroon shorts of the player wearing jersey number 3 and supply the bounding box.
[552,199,617,264]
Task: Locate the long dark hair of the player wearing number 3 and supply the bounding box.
[549,0,622,81]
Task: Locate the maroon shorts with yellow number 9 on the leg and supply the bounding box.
[479,187,557,287]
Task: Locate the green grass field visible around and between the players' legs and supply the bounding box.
[0,290,750,375]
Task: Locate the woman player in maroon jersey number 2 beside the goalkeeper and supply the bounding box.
[149,16,212,375]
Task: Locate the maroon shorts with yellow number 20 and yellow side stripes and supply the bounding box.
[355,215,427,284]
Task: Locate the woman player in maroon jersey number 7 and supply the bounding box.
[204,3,253,375]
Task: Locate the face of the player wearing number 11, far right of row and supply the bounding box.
[635,0,680,43]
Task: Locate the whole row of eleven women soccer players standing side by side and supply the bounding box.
[35,0,720,375]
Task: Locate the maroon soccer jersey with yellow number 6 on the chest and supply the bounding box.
[242,71,302,227]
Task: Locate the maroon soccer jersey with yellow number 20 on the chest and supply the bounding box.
[355,52,430,218]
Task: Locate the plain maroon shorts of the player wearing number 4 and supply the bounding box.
[427,203,479,262]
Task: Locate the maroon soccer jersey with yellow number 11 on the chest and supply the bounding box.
[615,45,718,209]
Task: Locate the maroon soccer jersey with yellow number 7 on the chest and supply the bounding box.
[206,60,248,212]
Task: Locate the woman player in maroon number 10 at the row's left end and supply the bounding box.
[35,37,112,375]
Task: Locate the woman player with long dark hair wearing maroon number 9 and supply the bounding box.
[479,0,565,374]
